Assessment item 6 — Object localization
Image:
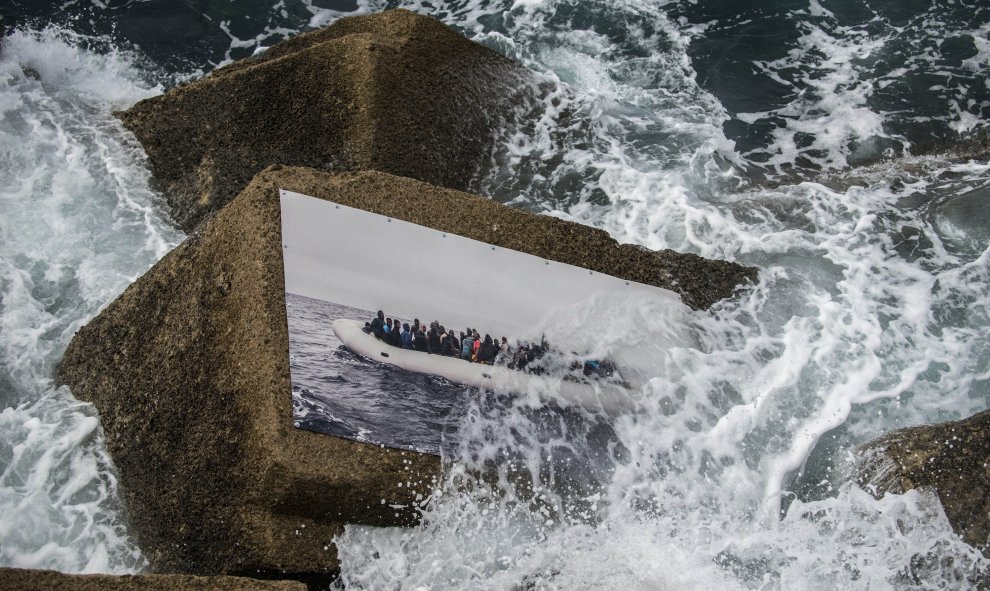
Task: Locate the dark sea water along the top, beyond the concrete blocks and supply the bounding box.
[0,0,990,180]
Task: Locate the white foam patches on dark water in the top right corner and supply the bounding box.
[736,2,988,174]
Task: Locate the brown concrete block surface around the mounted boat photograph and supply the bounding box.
[57,166,750,579]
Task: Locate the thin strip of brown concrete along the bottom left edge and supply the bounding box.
[0,568,306,591]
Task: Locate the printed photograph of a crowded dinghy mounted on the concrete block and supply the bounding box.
[281,191,685,453]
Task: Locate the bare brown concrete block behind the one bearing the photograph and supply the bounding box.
[120,10,535,232]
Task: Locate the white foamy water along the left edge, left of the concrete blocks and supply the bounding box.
[0,29,180,572]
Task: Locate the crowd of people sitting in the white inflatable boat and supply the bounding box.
[363,310,613,377]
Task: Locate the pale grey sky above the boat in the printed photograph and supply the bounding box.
[280,190,684,338]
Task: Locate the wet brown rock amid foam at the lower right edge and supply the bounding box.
[858,411,990,556]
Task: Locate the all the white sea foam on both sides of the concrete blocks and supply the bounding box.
[0,0,990,589]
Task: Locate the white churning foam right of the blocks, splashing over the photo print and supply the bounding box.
[338,1,990,589]
